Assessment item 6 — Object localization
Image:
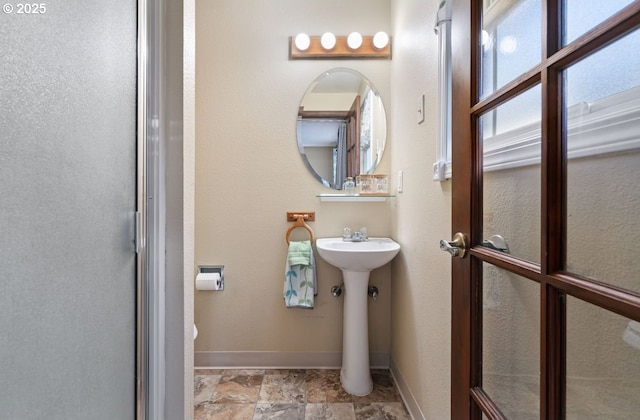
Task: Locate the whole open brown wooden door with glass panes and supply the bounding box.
[450,0,640,420]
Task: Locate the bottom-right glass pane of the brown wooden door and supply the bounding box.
[567,296,640,420]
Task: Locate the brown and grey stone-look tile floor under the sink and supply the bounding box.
[194,369,411,420]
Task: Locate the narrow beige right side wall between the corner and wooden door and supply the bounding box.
[390,0,455,419]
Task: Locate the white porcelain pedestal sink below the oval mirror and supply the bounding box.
[316,237,400,395]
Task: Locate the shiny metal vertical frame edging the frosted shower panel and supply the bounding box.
[136,0,166,420]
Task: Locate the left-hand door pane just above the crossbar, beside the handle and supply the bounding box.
[480,85,541,262]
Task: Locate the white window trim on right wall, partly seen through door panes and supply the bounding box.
[433,0,640,177]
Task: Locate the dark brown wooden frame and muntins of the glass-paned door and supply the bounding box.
[451,0,640,420]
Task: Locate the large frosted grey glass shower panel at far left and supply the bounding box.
[0,0,137,420]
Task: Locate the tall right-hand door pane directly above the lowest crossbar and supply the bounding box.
[564,31,640,292]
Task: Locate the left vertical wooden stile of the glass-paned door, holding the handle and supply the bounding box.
[451,0,481,419]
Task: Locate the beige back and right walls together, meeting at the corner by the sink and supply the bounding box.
[195,0,451,419]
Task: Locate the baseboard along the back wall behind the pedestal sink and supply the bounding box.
[194,351,389,369]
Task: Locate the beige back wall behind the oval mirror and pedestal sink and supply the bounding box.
[195,0,391,354]
